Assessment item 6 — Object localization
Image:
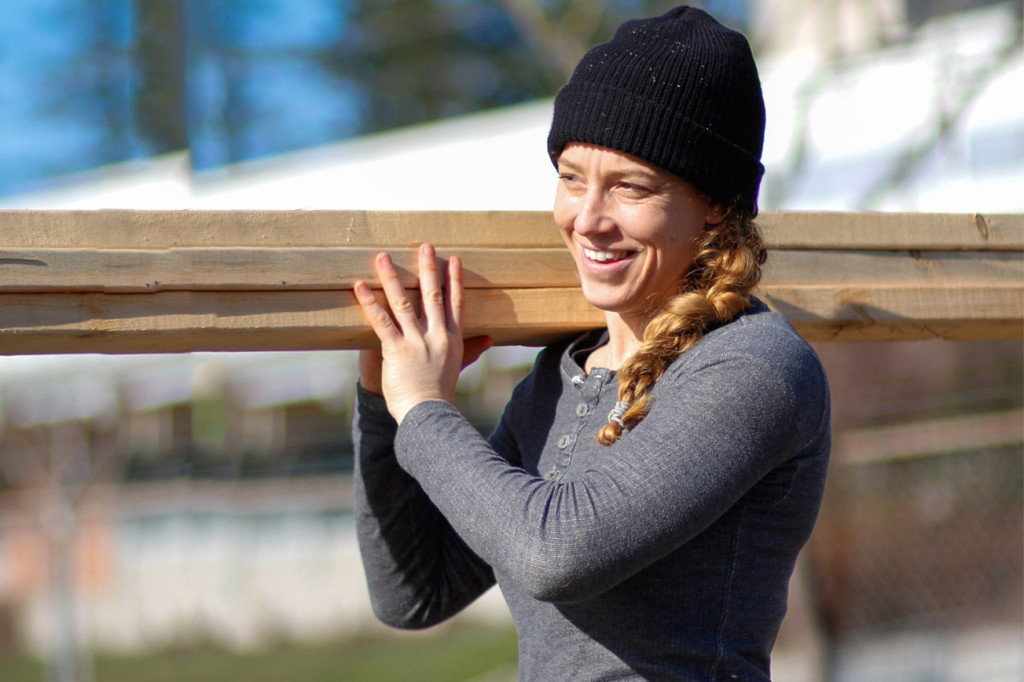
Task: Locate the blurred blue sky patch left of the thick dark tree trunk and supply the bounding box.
[0,0,138,188]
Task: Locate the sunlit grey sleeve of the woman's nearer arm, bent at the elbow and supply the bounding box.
[395,323,827,601]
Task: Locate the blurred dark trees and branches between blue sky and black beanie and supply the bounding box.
[321,0,708,132]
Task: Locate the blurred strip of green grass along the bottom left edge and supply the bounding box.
[0,628,517,682]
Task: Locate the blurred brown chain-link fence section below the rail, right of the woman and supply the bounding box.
[810,444,1024,636]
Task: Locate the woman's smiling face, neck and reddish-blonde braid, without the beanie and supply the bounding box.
[555,142,766,445]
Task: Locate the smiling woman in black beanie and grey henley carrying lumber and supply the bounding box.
[355,7,829,681]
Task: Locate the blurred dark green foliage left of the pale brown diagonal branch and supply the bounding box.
[319,0,551,132]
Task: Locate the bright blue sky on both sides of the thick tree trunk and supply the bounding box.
[0,0,360,194]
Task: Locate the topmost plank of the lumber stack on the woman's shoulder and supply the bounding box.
[0,210,1024,251]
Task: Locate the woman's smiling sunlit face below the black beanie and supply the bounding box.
[555,142,722,319]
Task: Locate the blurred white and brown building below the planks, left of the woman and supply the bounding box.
[0,349,525,651]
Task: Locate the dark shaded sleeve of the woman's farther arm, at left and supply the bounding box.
[353,387,495,629]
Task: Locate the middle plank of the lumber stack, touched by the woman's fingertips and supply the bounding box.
[0,247,1024,293]
